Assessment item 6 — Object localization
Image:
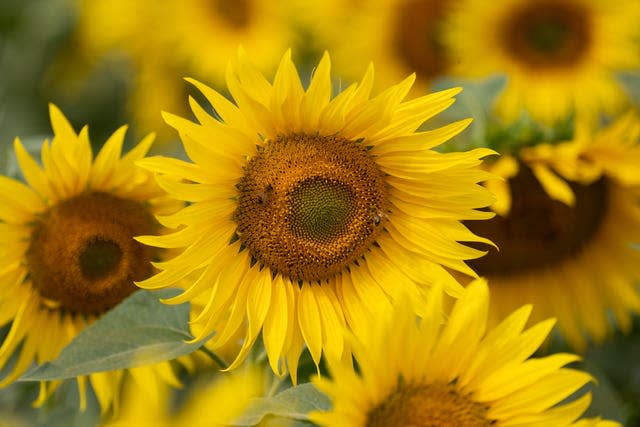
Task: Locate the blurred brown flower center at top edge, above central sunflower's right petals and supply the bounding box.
[395,0,448,79]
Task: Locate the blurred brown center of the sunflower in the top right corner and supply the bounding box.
[500,0,592,69]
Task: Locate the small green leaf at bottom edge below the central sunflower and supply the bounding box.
[231,383,331,426]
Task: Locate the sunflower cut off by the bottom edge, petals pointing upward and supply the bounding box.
[310,279,624,427]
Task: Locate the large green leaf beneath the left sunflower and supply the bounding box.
[20,290,201,381]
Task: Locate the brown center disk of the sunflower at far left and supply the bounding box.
[27,192,156,314]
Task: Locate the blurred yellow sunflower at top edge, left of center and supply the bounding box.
[48,0,298,147]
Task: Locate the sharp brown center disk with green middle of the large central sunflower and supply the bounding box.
[234,134,389,282]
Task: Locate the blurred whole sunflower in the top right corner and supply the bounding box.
[445,0,640,124]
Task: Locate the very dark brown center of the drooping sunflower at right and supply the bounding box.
[465,165,607,277]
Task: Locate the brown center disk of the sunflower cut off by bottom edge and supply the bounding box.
[366,384,492,427]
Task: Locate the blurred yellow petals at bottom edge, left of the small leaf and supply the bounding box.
[103,367,265,427]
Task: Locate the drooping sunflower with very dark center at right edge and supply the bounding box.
[467,113,640,350]
